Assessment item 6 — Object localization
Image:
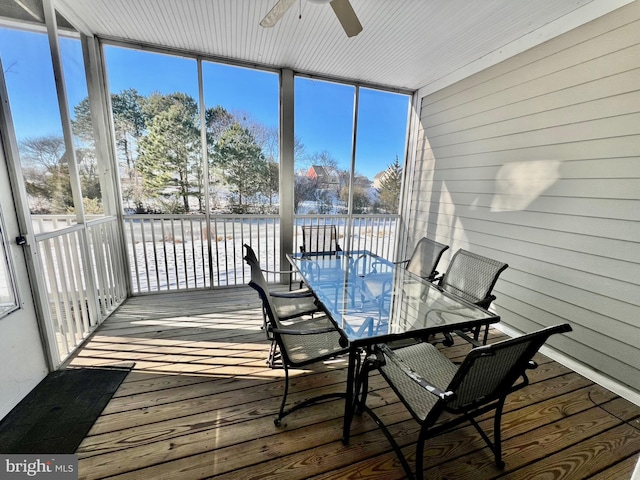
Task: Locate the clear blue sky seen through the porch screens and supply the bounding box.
[0,28,409,179]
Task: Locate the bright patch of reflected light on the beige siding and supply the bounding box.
[491,160,561,212]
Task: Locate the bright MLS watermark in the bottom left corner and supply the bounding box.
[0,454,78,480]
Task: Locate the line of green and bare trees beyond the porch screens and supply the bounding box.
[20,89,402,214]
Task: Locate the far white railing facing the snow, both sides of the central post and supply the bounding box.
[124,215,398,295]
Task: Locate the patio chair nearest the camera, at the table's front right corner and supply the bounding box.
[359,324,571,479]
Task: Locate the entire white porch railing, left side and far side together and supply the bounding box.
[32,215,398,363]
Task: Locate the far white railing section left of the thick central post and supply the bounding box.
[124,215,280,294]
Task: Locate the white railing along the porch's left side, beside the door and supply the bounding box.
[32,215,126,363]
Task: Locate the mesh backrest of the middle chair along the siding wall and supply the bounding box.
[439,249,509,308]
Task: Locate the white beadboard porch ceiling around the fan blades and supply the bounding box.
[54,0,630,91]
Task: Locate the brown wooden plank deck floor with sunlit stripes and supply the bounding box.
[70,287,640,480]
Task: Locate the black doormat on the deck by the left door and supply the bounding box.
[0,364,133,453]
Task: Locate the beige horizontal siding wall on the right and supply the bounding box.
[409,2,640,392]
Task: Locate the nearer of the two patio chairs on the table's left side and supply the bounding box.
[249,251,348,426]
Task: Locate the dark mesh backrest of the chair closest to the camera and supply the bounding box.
[446,323,572,411]
